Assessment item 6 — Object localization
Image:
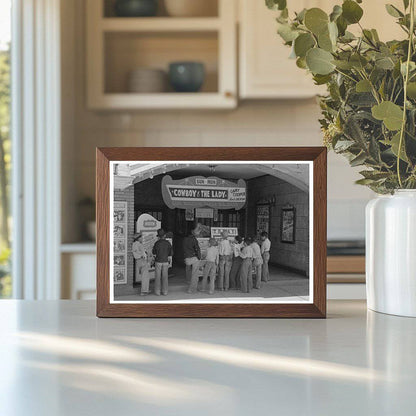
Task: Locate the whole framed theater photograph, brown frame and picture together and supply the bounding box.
[96,147,327,318]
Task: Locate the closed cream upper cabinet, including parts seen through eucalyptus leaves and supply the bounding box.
[239,0,404,99]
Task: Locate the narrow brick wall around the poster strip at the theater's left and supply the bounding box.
[114,186,137,297]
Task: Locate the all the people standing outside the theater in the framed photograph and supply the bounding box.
[132,229,271,296]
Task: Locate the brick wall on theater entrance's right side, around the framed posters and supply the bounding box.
[247,176,309,275]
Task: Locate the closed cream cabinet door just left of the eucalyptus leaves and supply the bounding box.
[239,0,321,98]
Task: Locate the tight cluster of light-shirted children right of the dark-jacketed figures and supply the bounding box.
[201,231,271,294]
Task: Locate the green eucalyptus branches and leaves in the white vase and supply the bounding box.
[266,0,416,194]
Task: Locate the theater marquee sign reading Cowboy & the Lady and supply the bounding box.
[162,175,247,210]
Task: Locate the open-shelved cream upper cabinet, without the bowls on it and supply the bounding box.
[86,0,237,109]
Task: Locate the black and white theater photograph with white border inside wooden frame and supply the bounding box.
[110,161,313,303]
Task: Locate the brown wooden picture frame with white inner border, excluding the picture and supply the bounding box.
[96,147,327,318]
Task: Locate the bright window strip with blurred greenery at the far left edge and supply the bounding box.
[0,0,12,298]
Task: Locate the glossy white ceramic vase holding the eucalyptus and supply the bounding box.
[366,190,416,317]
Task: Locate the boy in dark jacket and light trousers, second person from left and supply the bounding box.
[152,229,173,296]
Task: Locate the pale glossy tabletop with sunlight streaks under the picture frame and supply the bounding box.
[0,301,416,416]
